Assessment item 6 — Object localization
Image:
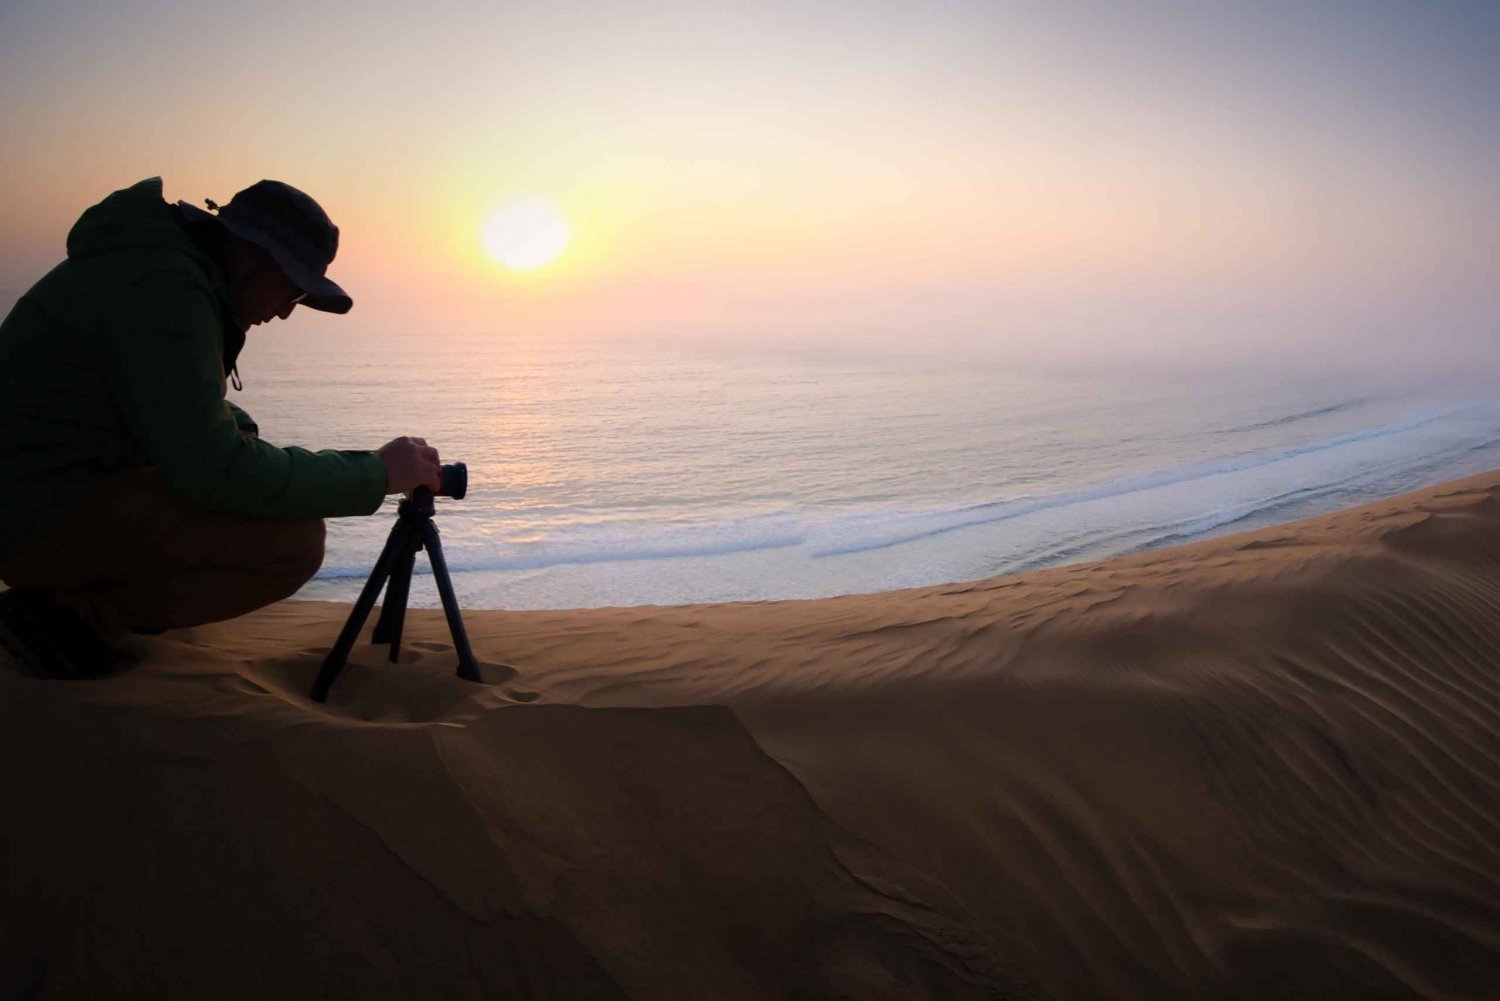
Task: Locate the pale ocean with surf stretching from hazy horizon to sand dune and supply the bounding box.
[231,324,1500,609]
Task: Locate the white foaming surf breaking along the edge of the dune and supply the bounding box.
[296,449,1496,611]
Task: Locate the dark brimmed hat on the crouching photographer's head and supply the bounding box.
[177,180,354,312]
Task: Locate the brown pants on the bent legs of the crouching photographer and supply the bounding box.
[0,468,324,639]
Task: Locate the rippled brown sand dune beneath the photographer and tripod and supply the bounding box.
[0,473,1500,999]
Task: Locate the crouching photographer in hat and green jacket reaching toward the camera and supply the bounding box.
[0,179,441,678]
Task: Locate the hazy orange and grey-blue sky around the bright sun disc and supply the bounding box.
[0,0,1500,372]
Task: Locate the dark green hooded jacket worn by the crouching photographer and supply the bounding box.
[0,177,386,560]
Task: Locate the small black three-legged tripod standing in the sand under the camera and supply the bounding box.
[312,486,480,702]
